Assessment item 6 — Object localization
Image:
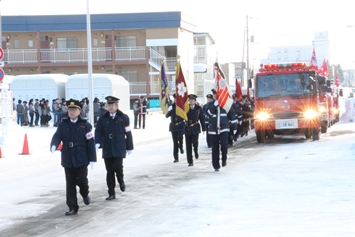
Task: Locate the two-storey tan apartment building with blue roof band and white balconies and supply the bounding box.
[2,12,196,98]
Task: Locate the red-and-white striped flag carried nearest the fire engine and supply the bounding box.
[214,63,233,112]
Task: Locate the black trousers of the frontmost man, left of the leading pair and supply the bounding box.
[64,166,89,211]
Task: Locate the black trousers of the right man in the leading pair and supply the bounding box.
[104,157,124,195]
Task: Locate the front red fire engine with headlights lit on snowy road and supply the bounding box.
[249,62,320,143]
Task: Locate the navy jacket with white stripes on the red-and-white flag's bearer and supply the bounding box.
[207,104,238,135]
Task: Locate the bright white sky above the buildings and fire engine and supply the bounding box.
[1,0,355,68]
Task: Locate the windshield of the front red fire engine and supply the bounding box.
[255,73,316,98]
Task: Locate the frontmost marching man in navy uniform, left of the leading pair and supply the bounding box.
[51,100,96,216]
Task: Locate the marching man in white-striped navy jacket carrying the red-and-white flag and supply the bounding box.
[207,90,238,171]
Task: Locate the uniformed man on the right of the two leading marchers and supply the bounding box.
[95,96,133,200]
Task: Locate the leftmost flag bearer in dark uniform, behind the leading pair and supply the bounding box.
[165,94,185,163]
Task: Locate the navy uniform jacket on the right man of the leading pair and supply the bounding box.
[95,110,133,158]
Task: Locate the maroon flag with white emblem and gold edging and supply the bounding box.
[175,61,190,120]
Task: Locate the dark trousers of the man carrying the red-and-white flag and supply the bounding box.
[211,132,229,169]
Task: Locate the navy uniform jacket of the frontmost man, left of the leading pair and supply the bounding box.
[50,116,96,168]
